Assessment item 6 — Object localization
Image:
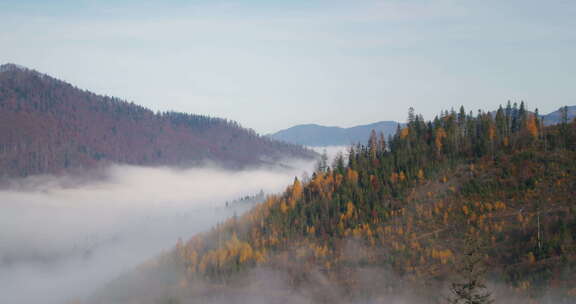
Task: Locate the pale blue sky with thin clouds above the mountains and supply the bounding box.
[0,0,576,134]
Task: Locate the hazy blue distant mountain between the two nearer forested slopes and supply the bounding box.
[269,121,399,146]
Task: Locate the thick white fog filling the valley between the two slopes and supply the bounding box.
[0,163,313,304]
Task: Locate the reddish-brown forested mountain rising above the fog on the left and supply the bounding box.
[0,64,315,177]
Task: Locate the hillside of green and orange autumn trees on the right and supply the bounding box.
[93,106,576,303]
